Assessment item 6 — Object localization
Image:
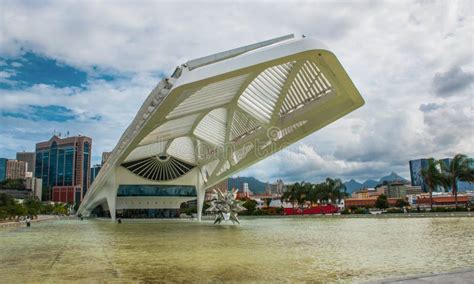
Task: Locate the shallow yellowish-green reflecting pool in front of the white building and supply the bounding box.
[0,217,474,283]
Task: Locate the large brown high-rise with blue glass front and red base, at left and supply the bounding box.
[35,135,92,203]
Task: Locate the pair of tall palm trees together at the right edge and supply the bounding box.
[421,154,474,209]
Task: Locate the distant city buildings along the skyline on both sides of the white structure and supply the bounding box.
[0,135,474,211]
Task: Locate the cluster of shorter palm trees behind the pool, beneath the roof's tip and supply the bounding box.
[281,178,348,211]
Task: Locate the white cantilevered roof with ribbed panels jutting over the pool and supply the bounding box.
[79,33,364,209]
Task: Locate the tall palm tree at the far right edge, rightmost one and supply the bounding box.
[440,154,474,208]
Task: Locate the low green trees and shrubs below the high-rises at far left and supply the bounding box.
[0,193,68,220]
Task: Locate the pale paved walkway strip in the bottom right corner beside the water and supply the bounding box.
[376,270,474,284]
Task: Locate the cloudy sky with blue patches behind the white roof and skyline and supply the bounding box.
[0,0,474,181]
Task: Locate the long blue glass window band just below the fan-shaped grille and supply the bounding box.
[117,185,196,197]
